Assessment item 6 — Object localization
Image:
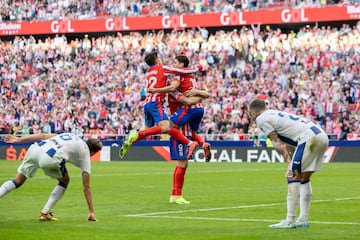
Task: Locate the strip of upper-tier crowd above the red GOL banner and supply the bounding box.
[0,0,360,22]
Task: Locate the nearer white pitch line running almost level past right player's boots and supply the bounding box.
[126,215,360,225]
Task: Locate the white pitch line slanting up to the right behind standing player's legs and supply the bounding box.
[124,197,360,217]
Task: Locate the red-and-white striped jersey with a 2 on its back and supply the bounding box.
[145,65,198,103]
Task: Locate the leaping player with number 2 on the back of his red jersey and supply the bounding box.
[119,52,201,158]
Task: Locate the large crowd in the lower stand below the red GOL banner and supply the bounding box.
[0,22,360,140]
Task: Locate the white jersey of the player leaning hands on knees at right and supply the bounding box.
[256,110,323,146]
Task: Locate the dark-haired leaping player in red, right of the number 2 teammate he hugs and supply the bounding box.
[148,55,211,162]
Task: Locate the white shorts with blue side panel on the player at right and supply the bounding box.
[291,132,329,173]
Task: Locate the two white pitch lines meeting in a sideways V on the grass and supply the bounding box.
[123,196,360,225]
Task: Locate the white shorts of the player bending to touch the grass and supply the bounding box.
[18,143,66,179]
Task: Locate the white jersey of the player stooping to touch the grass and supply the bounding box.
[38,133,91,174]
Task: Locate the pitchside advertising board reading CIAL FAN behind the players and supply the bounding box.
[0,141,360,163]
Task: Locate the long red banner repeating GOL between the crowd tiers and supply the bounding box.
[0,5,360,36]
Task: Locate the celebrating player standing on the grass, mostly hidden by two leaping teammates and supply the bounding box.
[168,85,209,204]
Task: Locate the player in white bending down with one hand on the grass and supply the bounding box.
[0,133,102,221]
